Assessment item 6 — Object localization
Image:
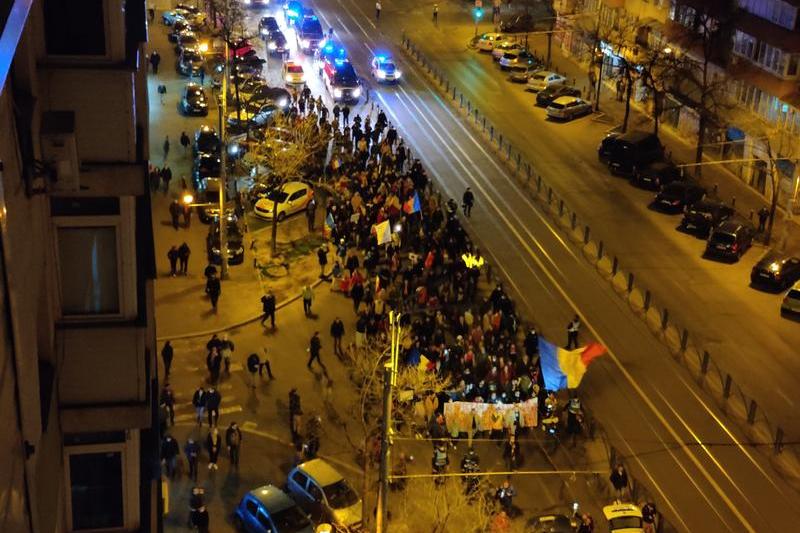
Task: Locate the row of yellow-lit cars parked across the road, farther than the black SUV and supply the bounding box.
[476,32,592,121]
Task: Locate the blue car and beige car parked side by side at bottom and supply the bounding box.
[233,459,363,533]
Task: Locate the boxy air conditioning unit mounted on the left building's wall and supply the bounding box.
[41,111,80,191]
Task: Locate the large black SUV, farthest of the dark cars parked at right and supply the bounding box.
[597,131,664,175]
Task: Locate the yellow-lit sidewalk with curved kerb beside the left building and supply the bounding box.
[148,19,322,341]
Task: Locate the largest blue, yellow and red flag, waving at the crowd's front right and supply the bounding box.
[539,337,606,391]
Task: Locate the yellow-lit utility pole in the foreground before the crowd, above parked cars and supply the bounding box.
[375,311,401,533]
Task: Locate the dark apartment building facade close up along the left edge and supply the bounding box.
[0,0,160,533]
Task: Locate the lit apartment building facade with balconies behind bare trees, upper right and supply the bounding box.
[556,0,800,212]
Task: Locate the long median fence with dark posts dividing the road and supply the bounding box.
[401,28,800,502]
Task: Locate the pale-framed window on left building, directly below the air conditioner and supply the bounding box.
[53,198,136,321]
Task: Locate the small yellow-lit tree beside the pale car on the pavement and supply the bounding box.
[245,112,328,254]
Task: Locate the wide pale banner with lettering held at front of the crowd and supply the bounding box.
[444,398,539,435]
